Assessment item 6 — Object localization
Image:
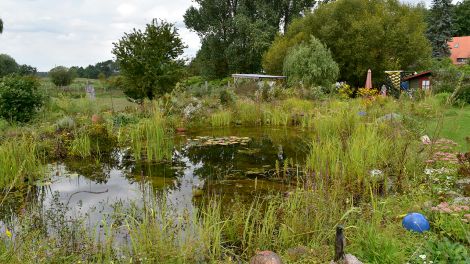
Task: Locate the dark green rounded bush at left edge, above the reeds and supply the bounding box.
[0,76,44,122]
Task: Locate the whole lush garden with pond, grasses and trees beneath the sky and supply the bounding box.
[0,0,470,264]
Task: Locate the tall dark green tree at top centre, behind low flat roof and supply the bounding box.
[184,0,318,78]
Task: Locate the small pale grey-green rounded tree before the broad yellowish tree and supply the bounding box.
[284,37,339,87]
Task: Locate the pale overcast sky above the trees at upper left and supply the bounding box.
[0,0,431,71]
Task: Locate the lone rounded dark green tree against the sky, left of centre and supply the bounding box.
[112,19,185,101]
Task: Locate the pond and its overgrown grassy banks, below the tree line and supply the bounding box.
[0,79,470,263]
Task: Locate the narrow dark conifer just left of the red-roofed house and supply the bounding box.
[427,0,453,58]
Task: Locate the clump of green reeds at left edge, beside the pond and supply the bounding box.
[0,137,45,188]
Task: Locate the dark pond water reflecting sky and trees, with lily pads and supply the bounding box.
[1,128,308,228]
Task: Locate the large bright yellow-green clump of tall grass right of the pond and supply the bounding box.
[306,102,420,197]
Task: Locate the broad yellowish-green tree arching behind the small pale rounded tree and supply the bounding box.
[263,0,431,86]
